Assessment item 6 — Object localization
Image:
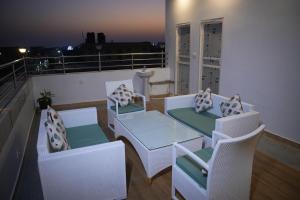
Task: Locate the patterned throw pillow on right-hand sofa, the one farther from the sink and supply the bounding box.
[220,94,244,117]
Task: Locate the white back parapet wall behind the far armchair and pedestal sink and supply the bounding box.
[32,68,170,105]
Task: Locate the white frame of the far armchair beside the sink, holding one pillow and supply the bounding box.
[105,79,146,131]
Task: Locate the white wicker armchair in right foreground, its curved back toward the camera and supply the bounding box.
[172,125,265,200]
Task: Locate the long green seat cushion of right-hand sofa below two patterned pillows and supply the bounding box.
[168,108,220,137]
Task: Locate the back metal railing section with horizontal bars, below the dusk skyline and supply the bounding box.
[25,52,165,74]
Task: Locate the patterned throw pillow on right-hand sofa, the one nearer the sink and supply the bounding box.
[195,88,213,112]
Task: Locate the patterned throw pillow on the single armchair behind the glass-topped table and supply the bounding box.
[110,84,134,107]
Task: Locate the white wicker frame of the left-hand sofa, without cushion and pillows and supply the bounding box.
[37,108,127,200]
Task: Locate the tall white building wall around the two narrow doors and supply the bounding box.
[166,0,300,143]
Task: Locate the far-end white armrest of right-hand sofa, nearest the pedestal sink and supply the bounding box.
[165,94,196,114]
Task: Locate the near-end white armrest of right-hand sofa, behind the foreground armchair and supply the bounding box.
[215,111,260,138]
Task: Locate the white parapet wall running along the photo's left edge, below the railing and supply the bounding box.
[0,80,35,199]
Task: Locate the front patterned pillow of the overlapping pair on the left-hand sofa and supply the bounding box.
[45,121,69,151]
